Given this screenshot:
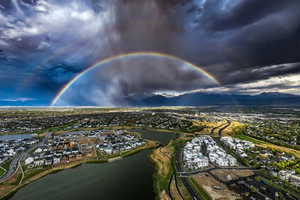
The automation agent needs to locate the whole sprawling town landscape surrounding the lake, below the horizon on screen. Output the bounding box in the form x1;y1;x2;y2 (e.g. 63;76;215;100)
0;107;300;200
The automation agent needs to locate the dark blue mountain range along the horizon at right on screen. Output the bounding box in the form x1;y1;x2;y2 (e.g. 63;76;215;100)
127;92;300;106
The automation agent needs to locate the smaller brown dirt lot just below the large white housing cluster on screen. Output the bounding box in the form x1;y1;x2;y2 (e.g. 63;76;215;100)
211;169;254;182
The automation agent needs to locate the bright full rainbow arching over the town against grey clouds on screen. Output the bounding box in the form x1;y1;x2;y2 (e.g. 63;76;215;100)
51;52;220;106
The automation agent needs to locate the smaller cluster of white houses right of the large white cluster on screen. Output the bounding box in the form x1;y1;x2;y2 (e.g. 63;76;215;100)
220;137;255;158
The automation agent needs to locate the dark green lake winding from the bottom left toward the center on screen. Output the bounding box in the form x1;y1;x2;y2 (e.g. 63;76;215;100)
11;131;175;200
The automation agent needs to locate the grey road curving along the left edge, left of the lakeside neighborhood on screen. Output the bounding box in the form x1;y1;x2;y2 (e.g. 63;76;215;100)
0;133;52;183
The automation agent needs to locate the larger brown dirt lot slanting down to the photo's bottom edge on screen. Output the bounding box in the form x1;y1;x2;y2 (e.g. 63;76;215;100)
193;173;240;200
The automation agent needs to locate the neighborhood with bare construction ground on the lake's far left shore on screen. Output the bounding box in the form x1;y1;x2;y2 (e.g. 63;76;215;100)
24;130;146;168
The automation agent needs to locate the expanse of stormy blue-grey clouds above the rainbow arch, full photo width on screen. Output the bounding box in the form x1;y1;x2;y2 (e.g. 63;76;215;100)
0;0;300;104
